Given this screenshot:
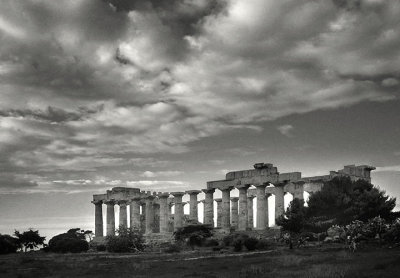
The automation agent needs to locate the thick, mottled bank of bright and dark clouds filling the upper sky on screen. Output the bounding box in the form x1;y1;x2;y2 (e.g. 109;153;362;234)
0;0;400;192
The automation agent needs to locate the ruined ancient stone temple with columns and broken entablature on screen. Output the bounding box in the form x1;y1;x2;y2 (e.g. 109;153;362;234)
92;163;375;237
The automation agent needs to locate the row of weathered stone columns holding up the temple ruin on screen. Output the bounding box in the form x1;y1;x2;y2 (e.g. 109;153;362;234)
93;184;290;236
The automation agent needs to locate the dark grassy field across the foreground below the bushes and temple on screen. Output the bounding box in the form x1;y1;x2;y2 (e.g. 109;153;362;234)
0;246;400;278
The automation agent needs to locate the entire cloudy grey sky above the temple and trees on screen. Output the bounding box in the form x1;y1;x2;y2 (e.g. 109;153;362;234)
0;0;400;238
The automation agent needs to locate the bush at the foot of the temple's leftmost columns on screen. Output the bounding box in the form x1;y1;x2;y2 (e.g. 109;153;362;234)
106;226;144;253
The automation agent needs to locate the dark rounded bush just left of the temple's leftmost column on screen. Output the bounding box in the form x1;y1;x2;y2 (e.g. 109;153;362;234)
45;229;89;253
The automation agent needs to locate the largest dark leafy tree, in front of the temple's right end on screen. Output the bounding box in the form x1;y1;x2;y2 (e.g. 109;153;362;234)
307;177;396;225
